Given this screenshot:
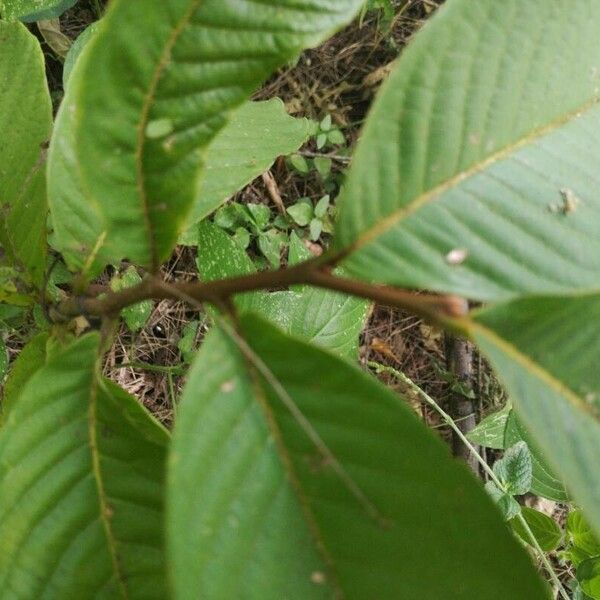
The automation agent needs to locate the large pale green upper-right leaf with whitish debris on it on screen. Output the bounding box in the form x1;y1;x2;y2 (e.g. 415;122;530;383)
336;0;600;300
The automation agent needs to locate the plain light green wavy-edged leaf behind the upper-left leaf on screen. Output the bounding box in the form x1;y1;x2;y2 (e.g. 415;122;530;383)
190;98;310;229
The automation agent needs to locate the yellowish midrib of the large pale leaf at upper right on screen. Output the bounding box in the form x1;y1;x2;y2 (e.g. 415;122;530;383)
343;97;600;254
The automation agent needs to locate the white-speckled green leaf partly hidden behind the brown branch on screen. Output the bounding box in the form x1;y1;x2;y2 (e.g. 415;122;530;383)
198;222;369;359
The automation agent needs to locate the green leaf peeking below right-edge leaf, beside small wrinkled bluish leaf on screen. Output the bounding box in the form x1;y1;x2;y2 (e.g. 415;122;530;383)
504;411;569;502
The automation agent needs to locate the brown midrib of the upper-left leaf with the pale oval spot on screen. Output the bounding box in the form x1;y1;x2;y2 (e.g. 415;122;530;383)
135;0;203;271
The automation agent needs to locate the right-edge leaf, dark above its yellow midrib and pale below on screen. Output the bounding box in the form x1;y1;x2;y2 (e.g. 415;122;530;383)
468;294;600;532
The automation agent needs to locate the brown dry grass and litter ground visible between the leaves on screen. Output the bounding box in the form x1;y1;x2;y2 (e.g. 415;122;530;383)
36;0;504;448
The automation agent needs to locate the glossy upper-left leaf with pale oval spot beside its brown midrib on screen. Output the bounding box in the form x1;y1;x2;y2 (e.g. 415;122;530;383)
57;0;361;268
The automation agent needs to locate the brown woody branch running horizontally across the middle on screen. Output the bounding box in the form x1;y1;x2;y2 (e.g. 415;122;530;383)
50;255;467;322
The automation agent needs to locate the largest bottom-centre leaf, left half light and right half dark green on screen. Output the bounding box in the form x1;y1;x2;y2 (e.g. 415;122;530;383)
167;315;546;600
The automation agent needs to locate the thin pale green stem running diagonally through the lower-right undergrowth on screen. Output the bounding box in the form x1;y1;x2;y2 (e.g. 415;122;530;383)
367;361;570;600
